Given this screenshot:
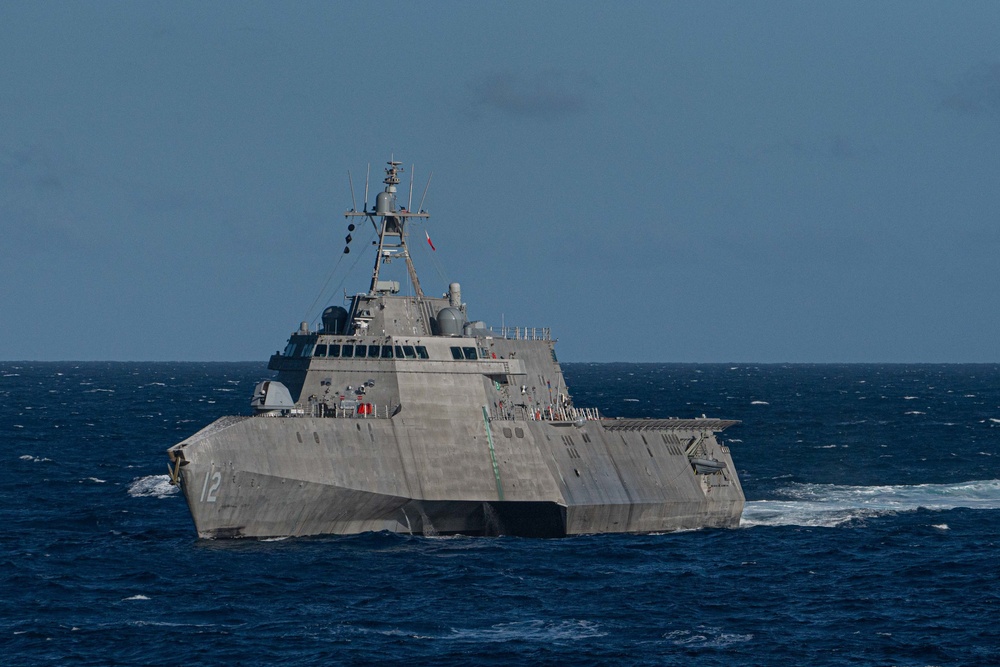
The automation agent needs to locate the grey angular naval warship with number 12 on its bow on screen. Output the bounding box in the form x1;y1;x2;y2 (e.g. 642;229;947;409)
168;161;744;538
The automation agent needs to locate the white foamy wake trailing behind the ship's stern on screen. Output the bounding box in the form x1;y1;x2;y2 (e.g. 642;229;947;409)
740;479;1000;528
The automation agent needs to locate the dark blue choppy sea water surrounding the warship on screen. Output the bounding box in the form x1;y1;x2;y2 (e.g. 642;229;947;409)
0;362;1000;665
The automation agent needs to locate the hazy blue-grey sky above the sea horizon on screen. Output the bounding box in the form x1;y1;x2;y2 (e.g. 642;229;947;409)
0;0;1000;363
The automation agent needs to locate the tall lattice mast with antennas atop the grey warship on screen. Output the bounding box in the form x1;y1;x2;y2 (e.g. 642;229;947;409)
344;160;430;298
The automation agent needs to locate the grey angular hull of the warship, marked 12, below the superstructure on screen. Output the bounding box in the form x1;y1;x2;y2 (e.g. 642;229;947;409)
170;416;744;538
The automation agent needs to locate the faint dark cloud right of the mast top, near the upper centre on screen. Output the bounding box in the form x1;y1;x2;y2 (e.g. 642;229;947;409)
469;71;586;120
